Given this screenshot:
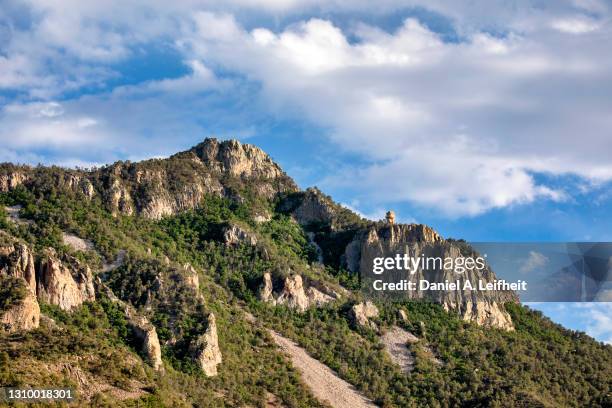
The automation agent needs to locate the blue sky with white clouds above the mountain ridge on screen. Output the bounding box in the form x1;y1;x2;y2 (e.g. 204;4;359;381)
0;0;612;341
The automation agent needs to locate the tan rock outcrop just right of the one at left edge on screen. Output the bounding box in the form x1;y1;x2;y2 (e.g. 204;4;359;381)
36;249;96;310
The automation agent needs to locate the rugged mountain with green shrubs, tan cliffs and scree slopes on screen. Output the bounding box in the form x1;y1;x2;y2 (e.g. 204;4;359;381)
0;139;612;407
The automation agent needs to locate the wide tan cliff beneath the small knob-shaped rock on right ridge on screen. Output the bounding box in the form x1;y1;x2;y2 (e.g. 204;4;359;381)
344;224;518;330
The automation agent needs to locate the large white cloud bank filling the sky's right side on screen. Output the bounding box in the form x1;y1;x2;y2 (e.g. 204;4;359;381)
175;12;612;215
